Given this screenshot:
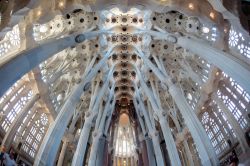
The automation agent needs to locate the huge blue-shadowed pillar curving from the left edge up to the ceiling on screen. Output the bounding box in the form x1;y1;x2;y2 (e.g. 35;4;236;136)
0;31;107;96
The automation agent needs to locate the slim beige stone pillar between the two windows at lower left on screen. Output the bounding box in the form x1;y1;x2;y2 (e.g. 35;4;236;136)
2;94;40;151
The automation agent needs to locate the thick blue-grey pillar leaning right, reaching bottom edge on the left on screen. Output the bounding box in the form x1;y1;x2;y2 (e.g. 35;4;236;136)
34;51;113;165
